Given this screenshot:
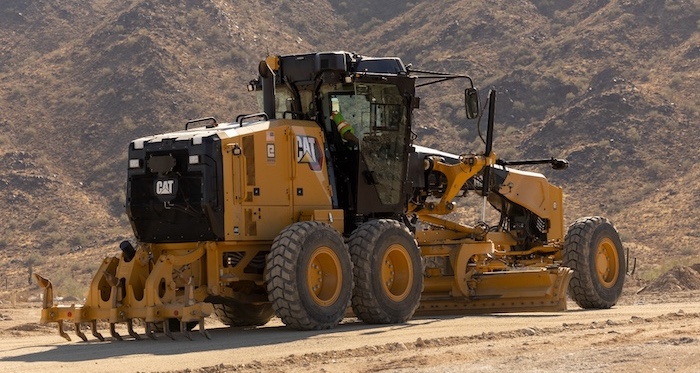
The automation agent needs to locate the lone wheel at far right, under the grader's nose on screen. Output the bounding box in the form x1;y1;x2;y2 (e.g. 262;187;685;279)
563;216;627;309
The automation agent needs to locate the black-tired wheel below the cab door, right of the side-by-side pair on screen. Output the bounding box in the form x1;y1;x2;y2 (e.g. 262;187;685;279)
349;219;423;324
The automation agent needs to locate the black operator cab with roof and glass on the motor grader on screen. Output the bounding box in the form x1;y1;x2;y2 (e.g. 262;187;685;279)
250;52;418;232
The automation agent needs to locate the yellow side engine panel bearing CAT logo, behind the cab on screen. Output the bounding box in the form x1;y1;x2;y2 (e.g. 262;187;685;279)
219;120;332;241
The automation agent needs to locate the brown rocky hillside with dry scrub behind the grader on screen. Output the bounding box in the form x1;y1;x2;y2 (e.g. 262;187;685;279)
0;0;700;296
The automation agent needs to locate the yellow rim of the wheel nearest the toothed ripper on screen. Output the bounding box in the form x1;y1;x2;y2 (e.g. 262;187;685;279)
306;246;343;307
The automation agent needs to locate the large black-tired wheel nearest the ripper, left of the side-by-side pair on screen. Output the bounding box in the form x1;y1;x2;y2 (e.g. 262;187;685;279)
265;221;352;330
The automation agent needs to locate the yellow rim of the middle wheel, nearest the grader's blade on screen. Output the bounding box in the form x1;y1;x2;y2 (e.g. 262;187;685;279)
381;244;413;302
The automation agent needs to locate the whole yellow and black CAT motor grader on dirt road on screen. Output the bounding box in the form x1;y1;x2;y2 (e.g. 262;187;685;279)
37;52;626;340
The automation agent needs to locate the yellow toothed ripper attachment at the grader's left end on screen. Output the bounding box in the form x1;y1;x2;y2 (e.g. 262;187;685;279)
35;241;214;341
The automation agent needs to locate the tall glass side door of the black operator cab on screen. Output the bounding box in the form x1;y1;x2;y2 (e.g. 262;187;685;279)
321;82;409;214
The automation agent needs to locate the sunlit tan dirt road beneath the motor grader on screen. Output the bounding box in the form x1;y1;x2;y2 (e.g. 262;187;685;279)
0;294;700;373
